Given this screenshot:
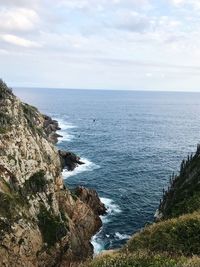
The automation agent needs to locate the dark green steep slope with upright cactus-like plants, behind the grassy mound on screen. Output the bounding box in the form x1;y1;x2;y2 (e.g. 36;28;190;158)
159;145;200;219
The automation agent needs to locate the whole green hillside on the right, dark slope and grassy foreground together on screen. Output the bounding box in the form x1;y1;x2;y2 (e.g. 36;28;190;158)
84;145;200;267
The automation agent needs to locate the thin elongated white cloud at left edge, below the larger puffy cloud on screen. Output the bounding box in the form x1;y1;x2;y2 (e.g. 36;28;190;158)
0;34;41;48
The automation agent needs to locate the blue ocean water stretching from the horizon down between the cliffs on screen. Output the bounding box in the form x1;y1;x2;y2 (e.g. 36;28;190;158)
14;88;200;253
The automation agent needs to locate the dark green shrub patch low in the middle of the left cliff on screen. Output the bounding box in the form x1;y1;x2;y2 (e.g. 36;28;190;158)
38;205;68;247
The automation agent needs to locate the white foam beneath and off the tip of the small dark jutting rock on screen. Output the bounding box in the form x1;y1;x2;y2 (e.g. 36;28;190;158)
62;158;100;179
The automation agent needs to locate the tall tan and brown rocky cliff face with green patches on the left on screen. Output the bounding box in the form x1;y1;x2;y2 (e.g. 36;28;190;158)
0;81;105;267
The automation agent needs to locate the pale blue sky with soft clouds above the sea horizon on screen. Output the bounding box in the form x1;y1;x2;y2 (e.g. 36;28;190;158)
0;0;200;91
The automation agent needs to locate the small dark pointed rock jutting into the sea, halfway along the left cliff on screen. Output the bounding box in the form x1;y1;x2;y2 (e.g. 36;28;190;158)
58;150;85;171
